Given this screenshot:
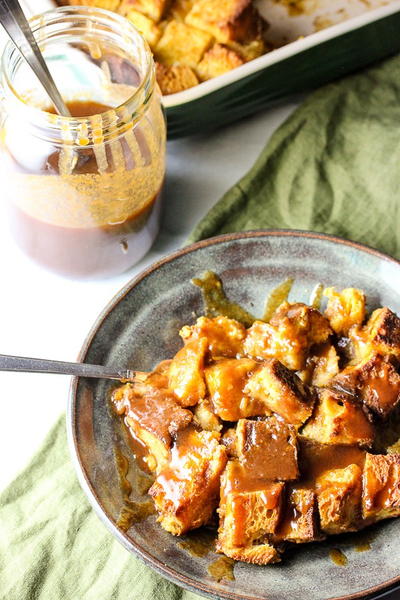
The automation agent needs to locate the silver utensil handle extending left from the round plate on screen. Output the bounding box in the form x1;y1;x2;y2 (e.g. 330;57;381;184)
0;354;135;380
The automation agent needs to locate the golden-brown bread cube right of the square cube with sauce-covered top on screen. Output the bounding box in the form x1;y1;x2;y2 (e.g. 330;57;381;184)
301;389;374;446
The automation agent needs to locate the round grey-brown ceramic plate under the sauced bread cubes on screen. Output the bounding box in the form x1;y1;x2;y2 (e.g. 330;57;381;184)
67;231;400;600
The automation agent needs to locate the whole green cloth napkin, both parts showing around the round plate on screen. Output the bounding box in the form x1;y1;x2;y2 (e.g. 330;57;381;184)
0;52;400;600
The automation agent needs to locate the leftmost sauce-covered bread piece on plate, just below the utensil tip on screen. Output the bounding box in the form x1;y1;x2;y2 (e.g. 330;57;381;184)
112;383;192;473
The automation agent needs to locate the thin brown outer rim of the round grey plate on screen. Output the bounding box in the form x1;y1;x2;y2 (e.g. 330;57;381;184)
66;229;400;600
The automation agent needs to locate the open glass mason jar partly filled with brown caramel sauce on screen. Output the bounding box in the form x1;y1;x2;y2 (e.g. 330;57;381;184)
0;6;166;278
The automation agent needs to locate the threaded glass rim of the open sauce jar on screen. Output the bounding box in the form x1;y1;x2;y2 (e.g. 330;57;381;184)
1;6;155;138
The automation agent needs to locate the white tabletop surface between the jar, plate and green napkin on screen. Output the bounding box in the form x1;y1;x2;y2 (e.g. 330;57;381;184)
0;100;297;488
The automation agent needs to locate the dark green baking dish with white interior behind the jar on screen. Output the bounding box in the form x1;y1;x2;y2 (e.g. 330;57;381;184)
163;0;400;139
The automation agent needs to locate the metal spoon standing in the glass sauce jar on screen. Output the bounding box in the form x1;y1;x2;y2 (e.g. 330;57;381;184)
0;0;71;117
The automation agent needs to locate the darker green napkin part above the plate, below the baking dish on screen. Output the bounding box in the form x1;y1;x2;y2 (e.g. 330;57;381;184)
190;56;400;258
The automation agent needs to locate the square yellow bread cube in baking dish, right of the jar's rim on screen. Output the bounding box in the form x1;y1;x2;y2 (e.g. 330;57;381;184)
155;21;212;69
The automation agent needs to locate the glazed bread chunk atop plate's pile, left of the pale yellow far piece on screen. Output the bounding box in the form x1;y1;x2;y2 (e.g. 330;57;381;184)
244;302;332;371
